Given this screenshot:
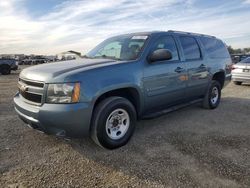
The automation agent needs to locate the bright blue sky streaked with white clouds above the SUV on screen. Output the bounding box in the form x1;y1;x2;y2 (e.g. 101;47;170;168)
0;0;250;54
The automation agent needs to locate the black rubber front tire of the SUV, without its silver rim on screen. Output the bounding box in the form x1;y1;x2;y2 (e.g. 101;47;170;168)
95;98;136;149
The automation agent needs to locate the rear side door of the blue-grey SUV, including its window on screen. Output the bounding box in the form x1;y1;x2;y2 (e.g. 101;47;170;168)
178;35;209;100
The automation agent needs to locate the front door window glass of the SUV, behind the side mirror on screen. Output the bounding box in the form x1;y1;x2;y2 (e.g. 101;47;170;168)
153;36;179;61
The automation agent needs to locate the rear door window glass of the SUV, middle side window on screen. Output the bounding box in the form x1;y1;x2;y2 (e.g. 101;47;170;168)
180;36;201;60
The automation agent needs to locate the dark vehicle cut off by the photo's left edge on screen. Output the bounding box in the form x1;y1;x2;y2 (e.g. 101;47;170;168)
0;59;18;75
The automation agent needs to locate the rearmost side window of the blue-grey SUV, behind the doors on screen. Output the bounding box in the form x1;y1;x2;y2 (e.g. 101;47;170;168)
201;37;229;58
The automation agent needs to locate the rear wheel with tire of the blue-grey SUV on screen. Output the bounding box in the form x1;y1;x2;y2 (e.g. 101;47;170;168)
203;80;221;109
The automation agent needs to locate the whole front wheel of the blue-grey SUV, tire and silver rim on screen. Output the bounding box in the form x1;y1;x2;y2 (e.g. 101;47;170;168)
91;97;136;149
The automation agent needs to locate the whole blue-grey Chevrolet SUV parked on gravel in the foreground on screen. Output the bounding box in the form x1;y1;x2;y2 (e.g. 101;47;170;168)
14;31;232;149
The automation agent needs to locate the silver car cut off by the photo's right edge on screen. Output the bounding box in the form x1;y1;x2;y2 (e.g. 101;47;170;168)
232;57;250;85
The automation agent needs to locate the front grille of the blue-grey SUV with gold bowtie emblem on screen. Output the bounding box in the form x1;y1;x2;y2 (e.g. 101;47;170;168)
18;78;44;104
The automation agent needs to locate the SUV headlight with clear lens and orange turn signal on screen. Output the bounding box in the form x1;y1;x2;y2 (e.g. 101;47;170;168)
46;83;80;103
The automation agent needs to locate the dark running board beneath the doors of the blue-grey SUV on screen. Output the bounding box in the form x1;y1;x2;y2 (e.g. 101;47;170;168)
142;99;203;119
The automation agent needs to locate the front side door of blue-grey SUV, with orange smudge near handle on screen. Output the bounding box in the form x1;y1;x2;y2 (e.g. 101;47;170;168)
143;35;186;111
